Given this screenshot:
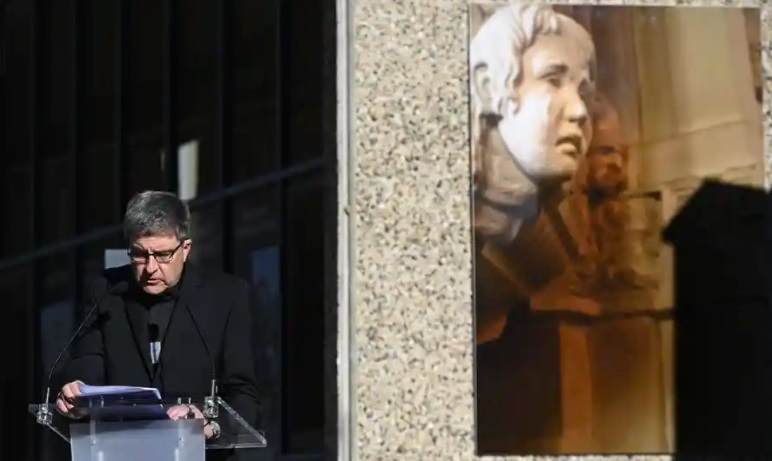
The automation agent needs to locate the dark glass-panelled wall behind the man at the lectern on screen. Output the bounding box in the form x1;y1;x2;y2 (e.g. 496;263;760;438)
0;0;335;459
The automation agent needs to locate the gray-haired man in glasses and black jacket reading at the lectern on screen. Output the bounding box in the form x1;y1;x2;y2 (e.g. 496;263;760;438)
56;191;258;452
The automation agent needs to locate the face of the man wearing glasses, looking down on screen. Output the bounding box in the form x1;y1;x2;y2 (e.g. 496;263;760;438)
129;233;192;295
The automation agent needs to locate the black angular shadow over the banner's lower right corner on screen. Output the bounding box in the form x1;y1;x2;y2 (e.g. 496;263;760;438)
663;180;772;461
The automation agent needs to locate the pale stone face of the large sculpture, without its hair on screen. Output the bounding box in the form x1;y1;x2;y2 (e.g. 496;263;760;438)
499;20;594;181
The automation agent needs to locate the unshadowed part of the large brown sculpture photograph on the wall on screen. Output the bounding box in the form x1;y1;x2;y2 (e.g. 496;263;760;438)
469;3;764;455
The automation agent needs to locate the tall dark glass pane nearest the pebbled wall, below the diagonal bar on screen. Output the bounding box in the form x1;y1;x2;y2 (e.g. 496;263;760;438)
282;172;325;453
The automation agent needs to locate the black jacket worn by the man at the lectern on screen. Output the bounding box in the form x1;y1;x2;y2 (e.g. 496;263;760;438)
55;263;259;446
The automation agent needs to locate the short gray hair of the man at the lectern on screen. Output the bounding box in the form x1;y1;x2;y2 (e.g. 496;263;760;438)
123;190;190;241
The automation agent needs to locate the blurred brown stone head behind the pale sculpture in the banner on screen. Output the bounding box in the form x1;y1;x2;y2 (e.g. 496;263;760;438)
587;109;628;194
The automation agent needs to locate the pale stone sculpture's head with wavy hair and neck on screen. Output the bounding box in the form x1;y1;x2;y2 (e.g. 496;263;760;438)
470;4;595;244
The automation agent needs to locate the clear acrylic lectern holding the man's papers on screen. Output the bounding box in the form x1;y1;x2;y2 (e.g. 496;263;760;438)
29;397;267;461
